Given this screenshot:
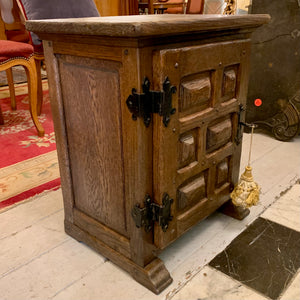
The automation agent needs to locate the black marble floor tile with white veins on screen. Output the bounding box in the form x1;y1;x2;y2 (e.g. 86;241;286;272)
210;218;300;299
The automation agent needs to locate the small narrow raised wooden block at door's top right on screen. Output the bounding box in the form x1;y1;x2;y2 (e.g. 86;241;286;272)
222;65;238;102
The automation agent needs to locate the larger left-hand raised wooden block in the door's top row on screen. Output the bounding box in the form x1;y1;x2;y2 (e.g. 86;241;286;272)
179;72;212;112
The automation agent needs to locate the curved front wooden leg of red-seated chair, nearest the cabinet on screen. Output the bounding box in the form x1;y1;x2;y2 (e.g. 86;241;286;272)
25;57;45;137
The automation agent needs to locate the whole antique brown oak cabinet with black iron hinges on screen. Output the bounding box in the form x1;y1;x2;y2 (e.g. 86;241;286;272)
27;15;269;293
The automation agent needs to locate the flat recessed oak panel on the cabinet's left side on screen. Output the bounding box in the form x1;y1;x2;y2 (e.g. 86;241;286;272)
58;55;127;236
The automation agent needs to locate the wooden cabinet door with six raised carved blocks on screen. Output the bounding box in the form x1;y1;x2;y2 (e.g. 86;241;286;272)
153;40;250;249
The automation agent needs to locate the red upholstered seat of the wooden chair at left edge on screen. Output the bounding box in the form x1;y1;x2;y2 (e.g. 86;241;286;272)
0;40;33;62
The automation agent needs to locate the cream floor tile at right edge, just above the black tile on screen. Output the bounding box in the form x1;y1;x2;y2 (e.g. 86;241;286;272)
261;184;300;231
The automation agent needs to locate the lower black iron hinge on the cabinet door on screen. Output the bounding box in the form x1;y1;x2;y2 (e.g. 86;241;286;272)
131;193;173;232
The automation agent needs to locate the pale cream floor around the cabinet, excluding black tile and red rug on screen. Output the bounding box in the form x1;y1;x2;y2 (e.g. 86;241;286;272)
0;134;300;300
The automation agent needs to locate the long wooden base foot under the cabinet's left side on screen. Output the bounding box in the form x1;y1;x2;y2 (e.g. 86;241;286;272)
65;220;173;294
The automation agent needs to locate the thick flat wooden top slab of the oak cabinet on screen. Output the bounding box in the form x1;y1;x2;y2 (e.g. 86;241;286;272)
26;14;270;37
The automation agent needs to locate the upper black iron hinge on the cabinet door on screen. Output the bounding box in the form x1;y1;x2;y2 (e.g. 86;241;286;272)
126;77;176;127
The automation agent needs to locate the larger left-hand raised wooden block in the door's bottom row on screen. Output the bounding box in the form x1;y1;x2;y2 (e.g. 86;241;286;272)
177;174;206;209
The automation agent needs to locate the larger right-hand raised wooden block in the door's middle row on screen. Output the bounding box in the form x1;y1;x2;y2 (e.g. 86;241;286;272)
206;118;232;152
